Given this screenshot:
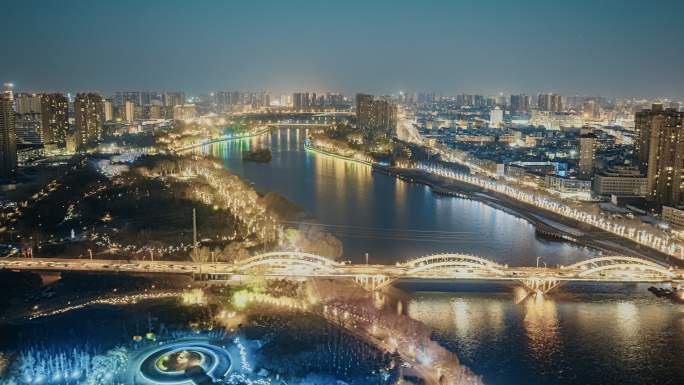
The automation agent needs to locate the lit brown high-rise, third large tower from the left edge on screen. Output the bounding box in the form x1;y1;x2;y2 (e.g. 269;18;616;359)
74;92;104;150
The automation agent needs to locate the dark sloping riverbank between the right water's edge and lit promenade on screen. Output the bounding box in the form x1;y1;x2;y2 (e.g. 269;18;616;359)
373;165;684;266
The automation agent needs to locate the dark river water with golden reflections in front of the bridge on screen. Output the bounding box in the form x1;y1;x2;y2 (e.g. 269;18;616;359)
406;285;684;385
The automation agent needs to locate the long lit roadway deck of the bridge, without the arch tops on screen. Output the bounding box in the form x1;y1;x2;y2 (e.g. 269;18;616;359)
0;257;684;282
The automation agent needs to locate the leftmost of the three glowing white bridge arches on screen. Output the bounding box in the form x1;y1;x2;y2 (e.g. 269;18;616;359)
235;251;341;275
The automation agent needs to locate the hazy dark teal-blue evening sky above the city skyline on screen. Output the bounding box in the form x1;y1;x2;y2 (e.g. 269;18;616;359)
0;0;684;97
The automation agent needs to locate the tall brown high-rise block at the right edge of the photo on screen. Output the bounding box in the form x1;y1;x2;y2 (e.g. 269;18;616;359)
634;104;684;206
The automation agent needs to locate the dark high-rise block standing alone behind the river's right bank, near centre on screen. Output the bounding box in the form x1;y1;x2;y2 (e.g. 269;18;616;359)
356;94;397;138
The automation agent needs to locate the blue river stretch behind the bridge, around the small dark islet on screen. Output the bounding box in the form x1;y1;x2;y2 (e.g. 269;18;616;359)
201;128;594;266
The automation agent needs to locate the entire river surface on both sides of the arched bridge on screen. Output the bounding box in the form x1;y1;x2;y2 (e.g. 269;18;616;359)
202;128;684;385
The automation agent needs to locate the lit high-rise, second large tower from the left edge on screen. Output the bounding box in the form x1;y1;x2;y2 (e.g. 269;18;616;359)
40;94;69;147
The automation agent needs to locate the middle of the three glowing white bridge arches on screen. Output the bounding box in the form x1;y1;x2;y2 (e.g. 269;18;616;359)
399;254;506;276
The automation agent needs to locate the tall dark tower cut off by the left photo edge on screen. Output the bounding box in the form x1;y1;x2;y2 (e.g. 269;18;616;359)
0;84;17;178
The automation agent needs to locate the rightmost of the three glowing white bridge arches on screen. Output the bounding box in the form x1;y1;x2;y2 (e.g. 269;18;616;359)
561;255;676;281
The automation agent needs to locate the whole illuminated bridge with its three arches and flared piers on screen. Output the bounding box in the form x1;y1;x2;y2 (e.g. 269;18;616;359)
0;251;684;293
